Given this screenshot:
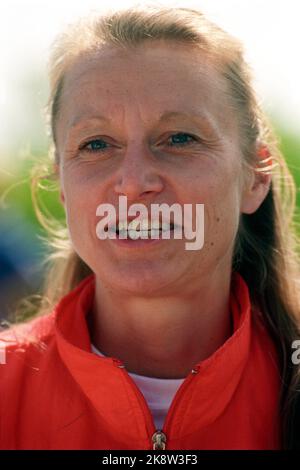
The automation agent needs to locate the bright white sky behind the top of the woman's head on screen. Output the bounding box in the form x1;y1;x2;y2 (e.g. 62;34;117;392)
0;0;300;167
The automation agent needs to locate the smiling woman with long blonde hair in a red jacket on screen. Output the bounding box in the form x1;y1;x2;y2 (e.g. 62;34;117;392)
0;7;299;450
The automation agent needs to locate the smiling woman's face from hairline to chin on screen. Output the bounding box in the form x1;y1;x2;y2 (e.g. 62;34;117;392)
56;42;257;294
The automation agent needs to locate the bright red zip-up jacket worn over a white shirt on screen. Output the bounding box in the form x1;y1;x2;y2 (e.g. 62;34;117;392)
0;273;280;450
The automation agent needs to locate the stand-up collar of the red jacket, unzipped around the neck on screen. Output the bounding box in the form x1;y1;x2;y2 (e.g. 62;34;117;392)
55;272;251;445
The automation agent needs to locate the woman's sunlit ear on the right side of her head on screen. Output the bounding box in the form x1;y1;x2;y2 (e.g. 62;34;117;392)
241;143;272;214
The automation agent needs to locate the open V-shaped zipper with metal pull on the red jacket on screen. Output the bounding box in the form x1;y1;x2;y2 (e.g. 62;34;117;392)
112;358;200;450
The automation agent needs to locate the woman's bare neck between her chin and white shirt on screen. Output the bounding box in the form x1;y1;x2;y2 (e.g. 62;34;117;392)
89;273;232;379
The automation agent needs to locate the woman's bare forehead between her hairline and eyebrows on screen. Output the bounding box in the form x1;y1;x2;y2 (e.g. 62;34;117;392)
61;41;235;135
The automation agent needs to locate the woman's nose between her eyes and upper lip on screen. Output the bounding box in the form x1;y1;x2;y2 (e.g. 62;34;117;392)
114;145;164;201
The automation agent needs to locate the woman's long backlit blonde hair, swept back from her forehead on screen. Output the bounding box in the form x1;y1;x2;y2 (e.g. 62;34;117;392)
24;6;300;448
